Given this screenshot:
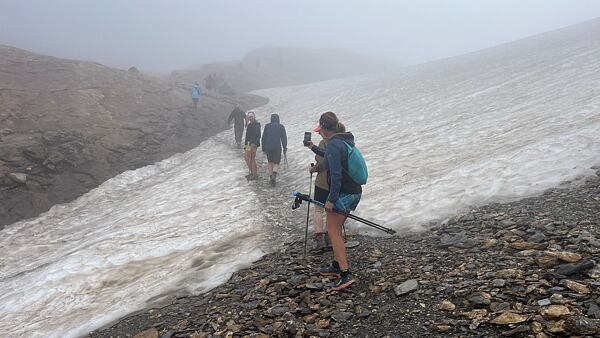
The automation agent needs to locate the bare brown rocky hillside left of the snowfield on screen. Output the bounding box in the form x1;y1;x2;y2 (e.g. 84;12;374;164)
0;45;268;229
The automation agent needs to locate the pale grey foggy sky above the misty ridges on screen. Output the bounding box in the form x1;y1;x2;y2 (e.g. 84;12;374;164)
0;0;600;71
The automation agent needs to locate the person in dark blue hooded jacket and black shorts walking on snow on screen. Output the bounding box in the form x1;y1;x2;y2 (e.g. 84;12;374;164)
262;114;287;186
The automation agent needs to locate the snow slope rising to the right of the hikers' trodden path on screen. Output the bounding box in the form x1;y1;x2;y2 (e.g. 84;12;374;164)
250;20;600;228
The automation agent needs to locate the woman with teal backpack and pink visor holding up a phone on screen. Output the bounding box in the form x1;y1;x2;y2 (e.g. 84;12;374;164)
307;112;362;291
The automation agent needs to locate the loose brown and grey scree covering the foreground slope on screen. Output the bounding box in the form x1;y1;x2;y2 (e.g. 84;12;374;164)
88;171;600;338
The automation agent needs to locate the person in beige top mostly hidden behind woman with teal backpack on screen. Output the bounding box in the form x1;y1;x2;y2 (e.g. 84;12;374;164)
309;117;346;252
